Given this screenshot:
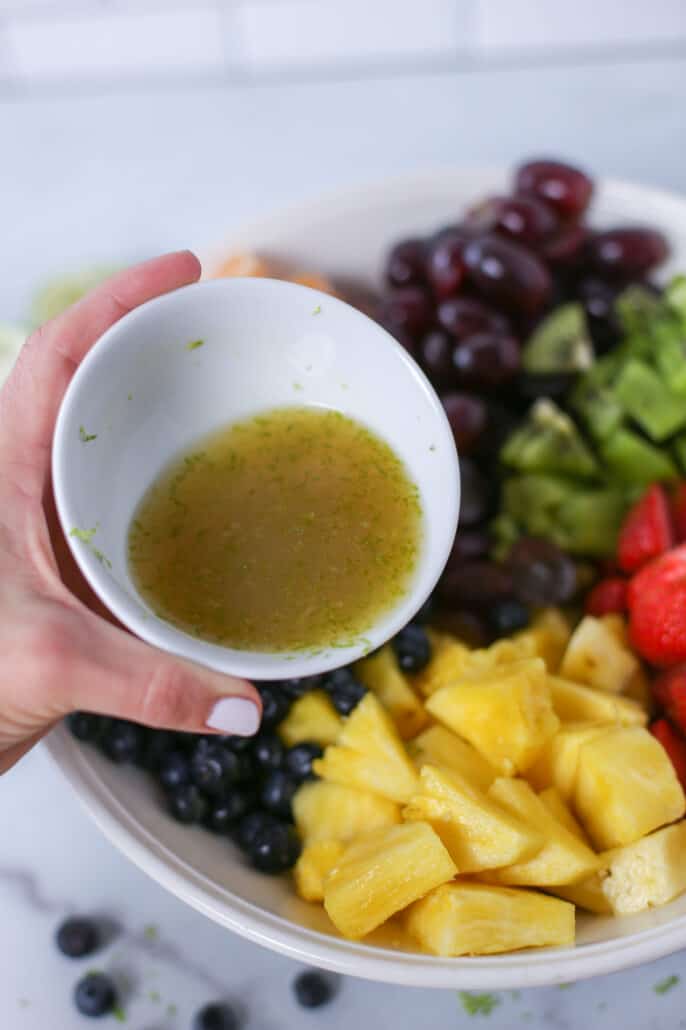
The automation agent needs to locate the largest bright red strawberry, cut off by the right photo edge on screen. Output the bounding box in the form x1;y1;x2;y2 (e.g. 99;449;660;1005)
627;544;686;667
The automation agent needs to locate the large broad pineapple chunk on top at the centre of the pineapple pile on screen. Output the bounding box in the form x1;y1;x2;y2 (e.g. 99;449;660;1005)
426;658;559;776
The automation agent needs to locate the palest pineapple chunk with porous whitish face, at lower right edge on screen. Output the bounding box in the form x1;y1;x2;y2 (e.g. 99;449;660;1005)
602;822;686;916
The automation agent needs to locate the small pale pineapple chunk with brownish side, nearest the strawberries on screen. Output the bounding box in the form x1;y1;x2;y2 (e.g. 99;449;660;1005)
559;615;640;694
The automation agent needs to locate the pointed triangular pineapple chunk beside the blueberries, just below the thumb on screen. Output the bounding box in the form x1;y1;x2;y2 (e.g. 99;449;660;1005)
312;693;418;802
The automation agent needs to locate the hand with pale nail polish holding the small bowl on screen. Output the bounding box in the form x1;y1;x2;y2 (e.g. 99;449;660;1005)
0;251;262;773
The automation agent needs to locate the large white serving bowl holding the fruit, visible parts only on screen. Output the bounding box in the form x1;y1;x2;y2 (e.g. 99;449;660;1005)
47;170;686;989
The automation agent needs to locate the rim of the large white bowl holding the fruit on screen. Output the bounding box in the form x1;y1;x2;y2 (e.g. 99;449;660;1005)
43;164;686;990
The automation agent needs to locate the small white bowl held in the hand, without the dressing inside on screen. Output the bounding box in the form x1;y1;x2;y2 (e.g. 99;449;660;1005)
53;278;459;680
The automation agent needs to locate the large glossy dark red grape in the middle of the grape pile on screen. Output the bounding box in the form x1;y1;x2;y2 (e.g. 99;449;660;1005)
462;234;551;315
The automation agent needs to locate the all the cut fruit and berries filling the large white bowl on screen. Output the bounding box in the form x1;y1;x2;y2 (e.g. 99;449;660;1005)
69;161;686;956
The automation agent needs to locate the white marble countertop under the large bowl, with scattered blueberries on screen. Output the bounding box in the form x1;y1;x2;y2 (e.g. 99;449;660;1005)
0;59;686;1030
